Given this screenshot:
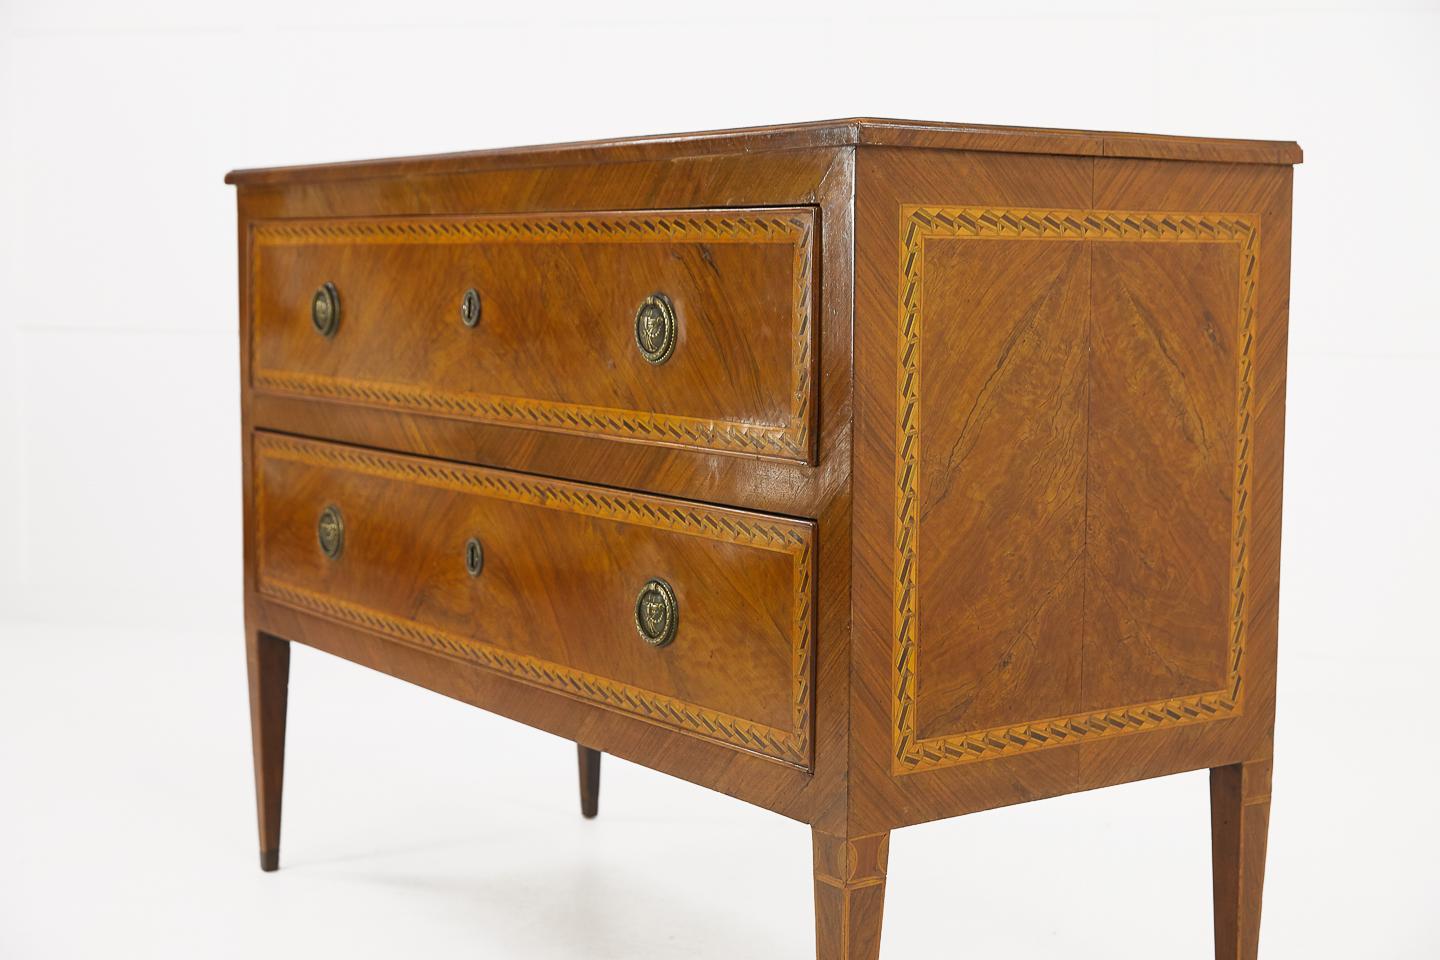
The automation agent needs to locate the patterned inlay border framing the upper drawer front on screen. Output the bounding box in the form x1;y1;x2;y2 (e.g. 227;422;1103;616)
252;209;815;462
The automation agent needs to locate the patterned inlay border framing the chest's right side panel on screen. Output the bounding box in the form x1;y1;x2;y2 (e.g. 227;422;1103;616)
891;204;1260;774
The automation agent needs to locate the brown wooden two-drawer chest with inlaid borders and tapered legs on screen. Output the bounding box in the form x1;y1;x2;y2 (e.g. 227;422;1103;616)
229;119;1300;960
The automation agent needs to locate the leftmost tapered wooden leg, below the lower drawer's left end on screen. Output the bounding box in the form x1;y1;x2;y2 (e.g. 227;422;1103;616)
246;630;289;871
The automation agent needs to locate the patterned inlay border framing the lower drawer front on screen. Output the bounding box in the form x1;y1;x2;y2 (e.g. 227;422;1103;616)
255;435;814;770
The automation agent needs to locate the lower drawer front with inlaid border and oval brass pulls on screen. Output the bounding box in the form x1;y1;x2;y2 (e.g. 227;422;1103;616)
253;433;814;769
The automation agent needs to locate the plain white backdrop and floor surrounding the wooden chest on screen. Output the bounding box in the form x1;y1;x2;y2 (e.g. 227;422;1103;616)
0;0;1440;960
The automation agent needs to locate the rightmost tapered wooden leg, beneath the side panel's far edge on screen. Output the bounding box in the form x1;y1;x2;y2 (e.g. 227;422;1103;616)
1210;760;1270;960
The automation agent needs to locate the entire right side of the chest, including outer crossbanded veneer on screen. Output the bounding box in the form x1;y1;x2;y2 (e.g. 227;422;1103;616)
852;150;1290;832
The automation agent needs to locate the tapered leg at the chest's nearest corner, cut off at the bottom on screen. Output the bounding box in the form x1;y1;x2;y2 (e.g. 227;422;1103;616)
812;830;890;960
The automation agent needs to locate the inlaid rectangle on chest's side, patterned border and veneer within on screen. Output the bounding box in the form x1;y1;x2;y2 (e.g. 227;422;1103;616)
893;206;1259;773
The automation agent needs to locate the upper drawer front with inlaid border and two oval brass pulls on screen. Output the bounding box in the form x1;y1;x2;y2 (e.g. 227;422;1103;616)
241;209;815;461
